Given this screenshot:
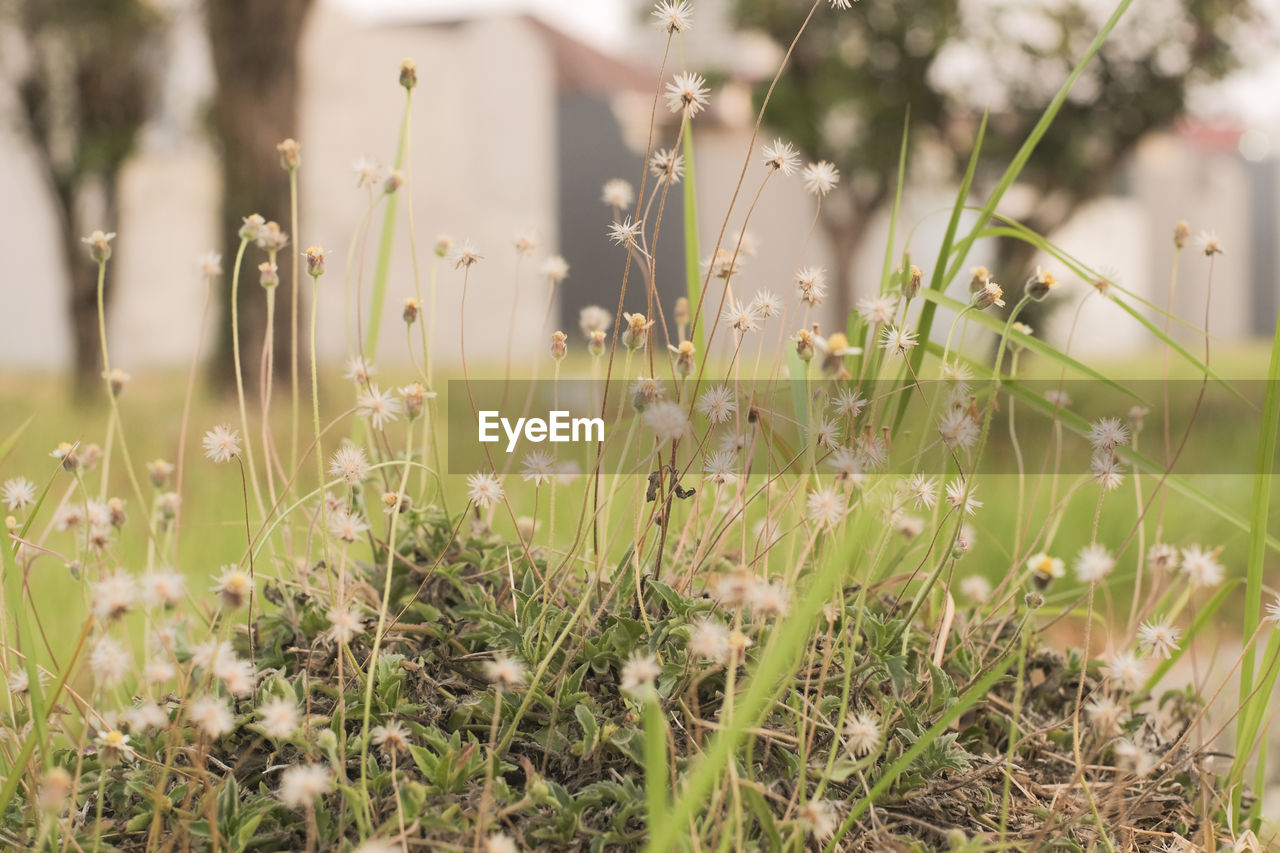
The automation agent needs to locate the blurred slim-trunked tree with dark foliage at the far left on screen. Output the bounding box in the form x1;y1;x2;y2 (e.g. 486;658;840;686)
4;0;164;396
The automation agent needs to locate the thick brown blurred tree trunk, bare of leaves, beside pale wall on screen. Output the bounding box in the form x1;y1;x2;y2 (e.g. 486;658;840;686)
205;0;312;386
